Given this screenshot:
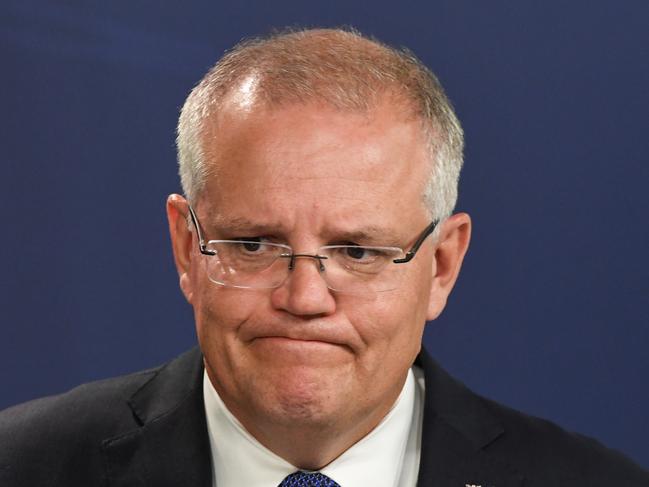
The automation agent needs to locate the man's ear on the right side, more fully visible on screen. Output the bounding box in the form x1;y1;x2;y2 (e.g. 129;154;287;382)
426;213;471;321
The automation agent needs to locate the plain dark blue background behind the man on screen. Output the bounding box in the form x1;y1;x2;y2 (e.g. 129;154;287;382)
0;0;649;467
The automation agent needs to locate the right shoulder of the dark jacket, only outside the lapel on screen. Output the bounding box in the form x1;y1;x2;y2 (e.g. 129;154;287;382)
480;388;649;487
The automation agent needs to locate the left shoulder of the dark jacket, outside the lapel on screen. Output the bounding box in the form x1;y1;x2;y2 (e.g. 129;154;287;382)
0;360;159;486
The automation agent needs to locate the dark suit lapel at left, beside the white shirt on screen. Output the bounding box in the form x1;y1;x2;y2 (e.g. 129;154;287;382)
102;349;212;487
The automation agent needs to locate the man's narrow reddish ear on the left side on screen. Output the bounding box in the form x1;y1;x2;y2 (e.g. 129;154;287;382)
167;194;193;303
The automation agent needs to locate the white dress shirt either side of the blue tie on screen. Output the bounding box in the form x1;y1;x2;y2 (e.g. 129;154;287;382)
203;367;424;487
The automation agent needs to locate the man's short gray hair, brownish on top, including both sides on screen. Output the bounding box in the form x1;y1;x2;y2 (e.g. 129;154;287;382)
176;29;464;219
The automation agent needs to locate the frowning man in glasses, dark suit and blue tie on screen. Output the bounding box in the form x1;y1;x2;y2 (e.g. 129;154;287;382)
0;30;649;487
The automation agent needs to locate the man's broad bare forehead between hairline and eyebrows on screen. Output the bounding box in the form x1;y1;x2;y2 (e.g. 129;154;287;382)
201;104;429;231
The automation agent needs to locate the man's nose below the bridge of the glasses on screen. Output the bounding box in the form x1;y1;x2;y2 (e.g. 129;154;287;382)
272;254;336;317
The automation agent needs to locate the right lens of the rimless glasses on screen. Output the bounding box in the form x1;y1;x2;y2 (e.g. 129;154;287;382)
318;245;405;294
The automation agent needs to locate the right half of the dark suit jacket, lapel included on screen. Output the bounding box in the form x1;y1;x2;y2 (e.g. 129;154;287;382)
417;351;649;487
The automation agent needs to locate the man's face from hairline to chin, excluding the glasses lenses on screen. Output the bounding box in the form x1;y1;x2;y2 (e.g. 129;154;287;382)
167;97;461;440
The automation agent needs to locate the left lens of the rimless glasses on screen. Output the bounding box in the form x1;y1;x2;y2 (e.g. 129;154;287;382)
206;240;291;289
